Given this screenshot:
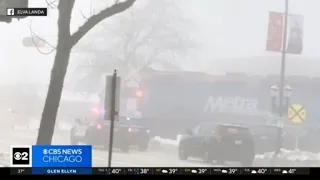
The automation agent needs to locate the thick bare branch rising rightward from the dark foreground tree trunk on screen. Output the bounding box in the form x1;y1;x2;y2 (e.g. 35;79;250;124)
71;0;136;46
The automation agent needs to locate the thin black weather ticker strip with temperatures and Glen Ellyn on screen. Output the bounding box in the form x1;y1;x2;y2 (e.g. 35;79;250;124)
6;167;314;175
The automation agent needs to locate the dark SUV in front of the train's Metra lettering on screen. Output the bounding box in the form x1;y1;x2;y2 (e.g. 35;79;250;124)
179;123;255;166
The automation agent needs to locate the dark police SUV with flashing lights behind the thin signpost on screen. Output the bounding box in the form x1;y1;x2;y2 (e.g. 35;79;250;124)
70;118;151;152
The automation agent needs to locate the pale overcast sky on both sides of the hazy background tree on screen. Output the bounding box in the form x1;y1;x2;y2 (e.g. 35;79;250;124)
0;0;320;84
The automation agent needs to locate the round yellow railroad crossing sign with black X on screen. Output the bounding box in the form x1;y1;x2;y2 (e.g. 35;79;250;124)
288;104;307;124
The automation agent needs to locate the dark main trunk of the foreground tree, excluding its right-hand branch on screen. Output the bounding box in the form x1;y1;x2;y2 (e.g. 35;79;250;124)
37;0;74;145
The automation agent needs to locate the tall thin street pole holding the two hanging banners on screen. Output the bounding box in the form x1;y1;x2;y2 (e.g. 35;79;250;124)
275;0;289;159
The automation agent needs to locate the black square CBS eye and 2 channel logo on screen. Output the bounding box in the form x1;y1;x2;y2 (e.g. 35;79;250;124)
11;147;30;166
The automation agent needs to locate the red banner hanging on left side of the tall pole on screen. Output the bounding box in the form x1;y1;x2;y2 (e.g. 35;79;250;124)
266;12;284;52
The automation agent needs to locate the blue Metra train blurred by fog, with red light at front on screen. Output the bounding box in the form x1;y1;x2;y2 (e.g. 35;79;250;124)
120;71;320;137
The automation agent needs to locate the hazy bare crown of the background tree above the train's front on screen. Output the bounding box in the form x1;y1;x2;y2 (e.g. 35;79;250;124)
71;0;194;90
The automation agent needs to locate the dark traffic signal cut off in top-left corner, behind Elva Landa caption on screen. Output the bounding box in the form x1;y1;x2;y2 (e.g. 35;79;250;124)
0;0;29;23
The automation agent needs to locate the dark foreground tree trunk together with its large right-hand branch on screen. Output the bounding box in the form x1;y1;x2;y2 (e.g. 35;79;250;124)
37;0;135;145
